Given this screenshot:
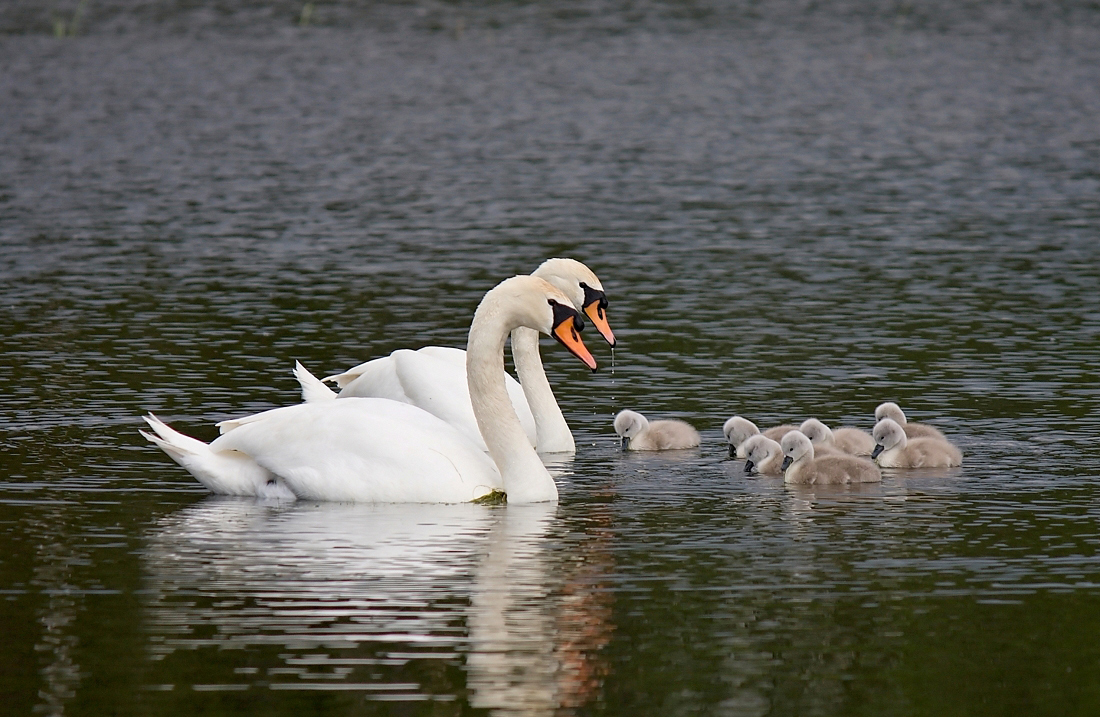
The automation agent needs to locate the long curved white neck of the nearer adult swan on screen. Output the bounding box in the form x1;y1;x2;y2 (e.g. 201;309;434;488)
466;295;558;503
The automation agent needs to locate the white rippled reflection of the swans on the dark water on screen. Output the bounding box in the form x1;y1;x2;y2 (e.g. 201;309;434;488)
143;490;613;714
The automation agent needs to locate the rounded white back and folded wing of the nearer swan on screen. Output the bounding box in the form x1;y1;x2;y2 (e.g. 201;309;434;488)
210;398;502;503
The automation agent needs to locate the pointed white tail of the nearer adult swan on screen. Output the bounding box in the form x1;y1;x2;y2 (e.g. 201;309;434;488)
139;413;279;498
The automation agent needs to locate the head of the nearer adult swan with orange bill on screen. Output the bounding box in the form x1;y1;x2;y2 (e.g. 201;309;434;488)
484;276;596;371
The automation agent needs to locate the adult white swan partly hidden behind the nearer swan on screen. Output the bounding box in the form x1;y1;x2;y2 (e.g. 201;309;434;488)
294;258;615;453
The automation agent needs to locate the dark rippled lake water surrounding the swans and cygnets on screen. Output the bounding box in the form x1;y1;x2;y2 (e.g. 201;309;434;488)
0;0;1100;715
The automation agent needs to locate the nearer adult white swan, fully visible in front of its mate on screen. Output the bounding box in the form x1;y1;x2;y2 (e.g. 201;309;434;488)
142;276;596;503
